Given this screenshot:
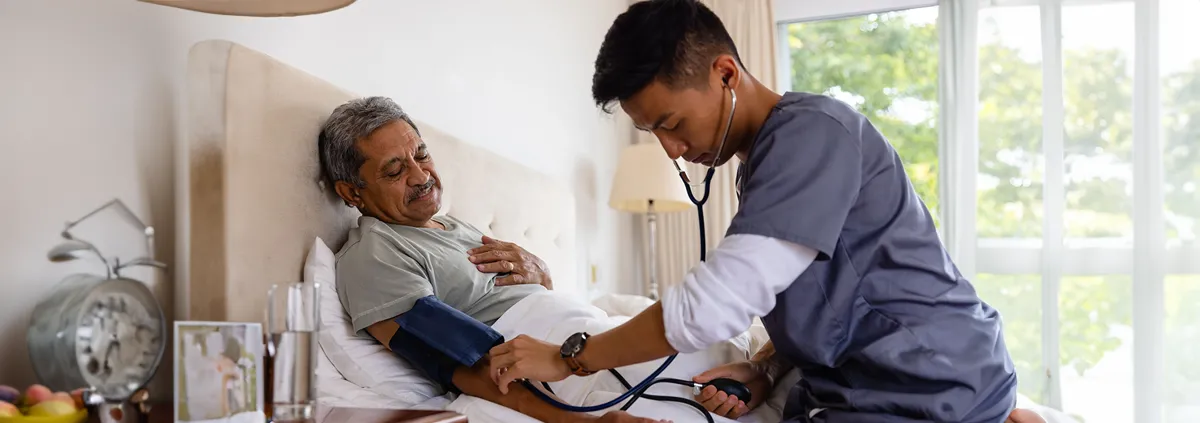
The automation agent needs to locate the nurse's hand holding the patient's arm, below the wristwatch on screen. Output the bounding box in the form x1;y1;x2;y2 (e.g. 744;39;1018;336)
488;335;571;394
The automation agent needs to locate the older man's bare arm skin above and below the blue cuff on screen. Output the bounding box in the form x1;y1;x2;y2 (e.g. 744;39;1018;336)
367;316;654;423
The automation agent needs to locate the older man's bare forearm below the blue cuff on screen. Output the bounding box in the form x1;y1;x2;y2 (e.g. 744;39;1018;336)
454;358;598;423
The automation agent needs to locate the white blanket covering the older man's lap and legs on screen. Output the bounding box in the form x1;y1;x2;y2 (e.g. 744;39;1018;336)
445;291;790;422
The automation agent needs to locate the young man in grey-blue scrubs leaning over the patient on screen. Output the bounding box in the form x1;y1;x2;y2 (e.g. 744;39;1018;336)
491;0;1042;423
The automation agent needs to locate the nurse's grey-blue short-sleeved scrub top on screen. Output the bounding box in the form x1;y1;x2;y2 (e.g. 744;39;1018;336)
727;93;1016;423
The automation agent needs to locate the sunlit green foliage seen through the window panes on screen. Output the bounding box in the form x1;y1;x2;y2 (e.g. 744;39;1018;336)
788;8;1200;408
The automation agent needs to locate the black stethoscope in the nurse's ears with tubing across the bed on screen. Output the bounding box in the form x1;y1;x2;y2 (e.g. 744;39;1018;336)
521;81;750;423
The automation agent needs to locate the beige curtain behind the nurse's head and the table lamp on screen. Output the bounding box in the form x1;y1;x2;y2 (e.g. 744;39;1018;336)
631;0;776;290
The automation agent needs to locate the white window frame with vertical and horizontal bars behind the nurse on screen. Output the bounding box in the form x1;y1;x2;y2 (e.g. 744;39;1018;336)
775;0;1185;415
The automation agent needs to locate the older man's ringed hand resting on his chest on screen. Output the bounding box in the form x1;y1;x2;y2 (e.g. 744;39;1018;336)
467;236;554;290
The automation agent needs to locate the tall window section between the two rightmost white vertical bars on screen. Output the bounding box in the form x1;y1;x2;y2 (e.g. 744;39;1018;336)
1048;2;1135;423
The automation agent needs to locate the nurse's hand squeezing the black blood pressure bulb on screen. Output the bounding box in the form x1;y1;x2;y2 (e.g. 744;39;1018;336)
691;361;770;418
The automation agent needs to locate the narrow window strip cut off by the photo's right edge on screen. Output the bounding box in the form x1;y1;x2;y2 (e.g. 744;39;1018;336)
1158;0;1200;423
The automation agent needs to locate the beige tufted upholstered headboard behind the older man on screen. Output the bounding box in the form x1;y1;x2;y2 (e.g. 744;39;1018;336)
184;41;584;322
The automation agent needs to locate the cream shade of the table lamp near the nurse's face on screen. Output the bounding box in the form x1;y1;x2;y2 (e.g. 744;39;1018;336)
608;143;695;213
